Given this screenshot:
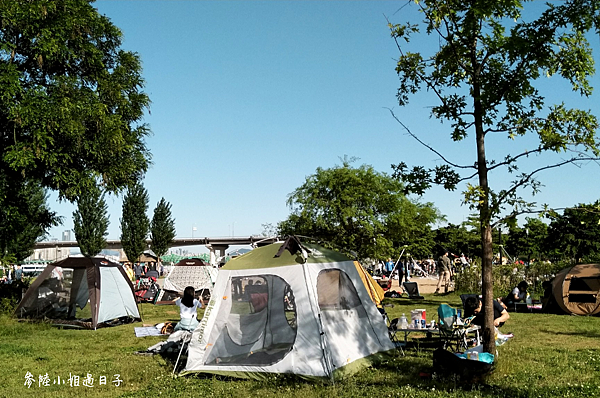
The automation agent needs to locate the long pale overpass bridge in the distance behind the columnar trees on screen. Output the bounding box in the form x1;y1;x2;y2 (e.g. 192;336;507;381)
34;236;279;265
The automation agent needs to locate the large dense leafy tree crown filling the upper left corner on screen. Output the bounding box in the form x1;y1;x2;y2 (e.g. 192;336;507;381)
0;0;151;257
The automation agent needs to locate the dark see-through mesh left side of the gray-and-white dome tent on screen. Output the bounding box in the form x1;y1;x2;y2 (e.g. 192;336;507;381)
18;267;92;321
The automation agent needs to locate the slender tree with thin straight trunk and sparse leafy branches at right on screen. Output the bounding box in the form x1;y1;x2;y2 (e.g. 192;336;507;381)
390;0;600;352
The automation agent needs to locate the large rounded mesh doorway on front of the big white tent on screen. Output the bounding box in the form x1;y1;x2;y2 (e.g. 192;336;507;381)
204;275;297;366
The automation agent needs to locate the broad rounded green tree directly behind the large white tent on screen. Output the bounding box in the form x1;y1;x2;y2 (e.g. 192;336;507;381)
278;160;439;259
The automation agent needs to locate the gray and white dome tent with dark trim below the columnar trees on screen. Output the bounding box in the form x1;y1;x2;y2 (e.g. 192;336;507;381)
15;257;140;329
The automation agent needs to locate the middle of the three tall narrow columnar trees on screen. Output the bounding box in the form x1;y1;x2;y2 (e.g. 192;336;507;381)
121;183;150;261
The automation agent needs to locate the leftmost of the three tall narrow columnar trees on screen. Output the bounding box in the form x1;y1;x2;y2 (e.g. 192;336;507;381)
73;183;110;257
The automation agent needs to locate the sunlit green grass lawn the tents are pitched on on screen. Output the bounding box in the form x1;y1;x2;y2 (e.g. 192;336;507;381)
0;294;600;398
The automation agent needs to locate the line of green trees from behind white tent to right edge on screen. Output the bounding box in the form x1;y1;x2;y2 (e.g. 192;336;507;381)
271;159;600;263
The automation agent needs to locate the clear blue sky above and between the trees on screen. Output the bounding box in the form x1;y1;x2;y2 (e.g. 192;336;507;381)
50;0;600;246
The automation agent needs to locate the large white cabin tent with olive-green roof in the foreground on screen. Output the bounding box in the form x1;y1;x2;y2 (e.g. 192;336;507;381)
184;237;394;379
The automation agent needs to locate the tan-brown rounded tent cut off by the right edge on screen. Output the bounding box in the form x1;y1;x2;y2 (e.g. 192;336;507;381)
552;264;600;315
